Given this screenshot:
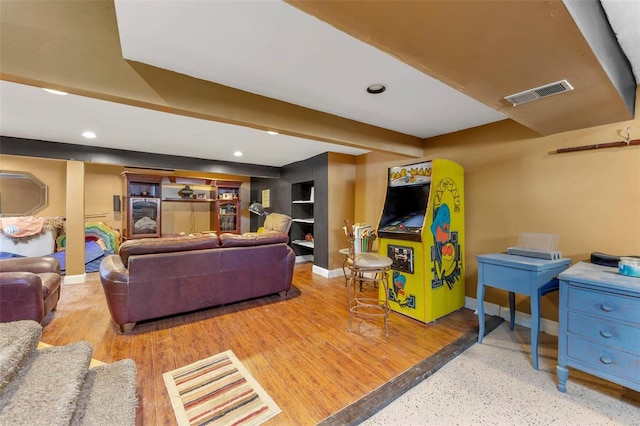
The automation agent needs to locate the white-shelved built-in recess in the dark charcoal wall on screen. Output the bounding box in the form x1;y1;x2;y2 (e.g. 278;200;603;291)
291;181;314;260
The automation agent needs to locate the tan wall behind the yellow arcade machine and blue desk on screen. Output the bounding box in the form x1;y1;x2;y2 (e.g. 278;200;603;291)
356;87;640;320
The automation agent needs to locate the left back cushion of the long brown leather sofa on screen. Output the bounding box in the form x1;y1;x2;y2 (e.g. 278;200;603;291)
118;234;220;265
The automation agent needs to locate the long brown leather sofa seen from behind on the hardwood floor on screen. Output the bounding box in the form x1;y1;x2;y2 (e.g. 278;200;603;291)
100;233;295;332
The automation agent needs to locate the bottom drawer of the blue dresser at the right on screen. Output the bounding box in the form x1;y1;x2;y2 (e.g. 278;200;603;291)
568;335;640;389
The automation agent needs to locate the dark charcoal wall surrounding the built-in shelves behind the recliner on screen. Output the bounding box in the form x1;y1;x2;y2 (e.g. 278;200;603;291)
251;153;329;269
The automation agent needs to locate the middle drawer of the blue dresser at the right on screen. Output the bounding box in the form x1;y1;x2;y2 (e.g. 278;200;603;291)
568;312;640;355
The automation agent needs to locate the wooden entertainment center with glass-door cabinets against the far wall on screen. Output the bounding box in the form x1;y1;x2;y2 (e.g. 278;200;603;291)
122;171;242;239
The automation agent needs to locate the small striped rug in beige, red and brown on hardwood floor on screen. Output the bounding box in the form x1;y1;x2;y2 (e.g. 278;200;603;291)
162;350;281;426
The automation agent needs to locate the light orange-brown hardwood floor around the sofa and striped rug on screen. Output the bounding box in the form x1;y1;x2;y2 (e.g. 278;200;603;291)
41;263;478;425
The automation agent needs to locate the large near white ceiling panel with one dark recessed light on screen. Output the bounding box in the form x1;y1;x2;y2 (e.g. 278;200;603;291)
115;0;505;138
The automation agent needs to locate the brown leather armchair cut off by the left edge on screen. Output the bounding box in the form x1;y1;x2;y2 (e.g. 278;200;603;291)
0;256;62;323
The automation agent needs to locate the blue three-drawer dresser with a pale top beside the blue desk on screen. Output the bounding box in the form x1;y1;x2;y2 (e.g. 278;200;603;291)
556;262;640;392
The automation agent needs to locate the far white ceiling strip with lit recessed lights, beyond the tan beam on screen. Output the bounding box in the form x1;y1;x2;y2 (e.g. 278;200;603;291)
0;81;367;167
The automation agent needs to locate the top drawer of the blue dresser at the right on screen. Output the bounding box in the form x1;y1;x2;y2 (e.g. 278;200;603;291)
568;286;640;324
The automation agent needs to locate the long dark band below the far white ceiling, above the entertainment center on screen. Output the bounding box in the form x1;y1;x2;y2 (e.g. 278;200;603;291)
0;136;280;178
